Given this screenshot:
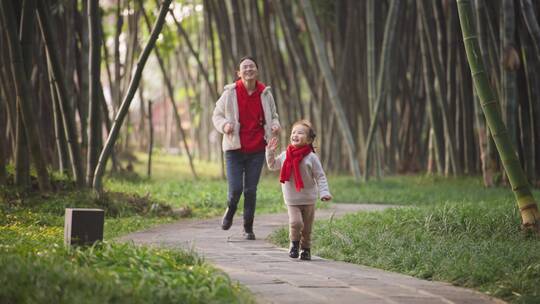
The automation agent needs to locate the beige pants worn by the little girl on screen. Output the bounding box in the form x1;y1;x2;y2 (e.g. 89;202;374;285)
287;204;315;248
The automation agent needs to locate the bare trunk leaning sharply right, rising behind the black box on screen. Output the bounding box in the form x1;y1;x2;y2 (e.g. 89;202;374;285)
93;0;172;194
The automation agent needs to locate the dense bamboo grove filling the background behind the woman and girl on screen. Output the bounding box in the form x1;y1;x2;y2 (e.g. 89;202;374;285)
0;0;540;191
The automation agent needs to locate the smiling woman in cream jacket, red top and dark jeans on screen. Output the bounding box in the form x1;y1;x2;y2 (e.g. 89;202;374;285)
212;57;280;240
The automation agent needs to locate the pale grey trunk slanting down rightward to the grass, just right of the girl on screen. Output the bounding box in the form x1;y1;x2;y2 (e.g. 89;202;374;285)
300;0;360;180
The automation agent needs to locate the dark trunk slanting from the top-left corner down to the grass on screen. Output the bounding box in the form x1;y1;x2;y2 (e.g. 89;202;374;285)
1;1;51;191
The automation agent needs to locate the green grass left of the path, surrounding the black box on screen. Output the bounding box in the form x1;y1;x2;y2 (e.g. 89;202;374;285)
0;154;253;303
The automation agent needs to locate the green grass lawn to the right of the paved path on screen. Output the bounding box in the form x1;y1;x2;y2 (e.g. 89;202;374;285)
271;176;540;303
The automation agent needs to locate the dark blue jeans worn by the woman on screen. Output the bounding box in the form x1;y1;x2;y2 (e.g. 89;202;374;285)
225;150;265;230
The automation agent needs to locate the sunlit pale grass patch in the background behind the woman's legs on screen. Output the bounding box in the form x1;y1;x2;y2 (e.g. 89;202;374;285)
105;153;286;218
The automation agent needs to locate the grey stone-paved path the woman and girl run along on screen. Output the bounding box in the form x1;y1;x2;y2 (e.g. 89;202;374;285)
121;204;504;304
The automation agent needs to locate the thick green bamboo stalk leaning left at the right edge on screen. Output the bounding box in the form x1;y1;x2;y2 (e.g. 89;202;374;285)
457;0;540;232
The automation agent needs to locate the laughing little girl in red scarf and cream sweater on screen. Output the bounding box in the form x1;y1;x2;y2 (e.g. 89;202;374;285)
266;120;332;260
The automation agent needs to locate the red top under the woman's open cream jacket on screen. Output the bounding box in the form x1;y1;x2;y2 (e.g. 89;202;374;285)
236;79;266;153
